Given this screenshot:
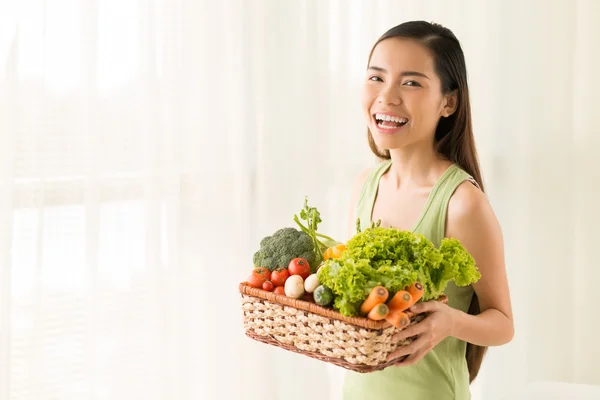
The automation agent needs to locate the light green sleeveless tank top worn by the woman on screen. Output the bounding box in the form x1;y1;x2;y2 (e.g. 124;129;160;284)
343;160;474;400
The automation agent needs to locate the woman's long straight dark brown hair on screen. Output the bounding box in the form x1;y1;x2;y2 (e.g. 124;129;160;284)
368;21;487;382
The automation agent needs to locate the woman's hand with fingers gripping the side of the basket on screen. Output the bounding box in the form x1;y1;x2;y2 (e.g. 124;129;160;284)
387;300;457;367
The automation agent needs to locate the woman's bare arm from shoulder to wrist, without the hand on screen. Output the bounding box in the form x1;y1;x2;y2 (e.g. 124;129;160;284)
446;183;514;346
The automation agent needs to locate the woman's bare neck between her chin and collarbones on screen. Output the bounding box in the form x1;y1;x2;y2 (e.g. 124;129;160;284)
387;146;452;189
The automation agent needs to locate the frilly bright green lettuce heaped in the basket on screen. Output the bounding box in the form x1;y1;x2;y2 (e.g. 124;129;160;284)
317;227;481;316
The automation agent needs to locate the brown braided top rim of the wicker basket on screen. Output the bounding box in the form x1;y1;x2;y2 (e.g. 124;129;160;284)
239;282;448;330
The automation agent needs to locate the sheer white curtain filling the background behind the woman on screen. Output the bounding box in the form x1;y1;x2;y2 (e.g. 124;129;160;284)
0;0;600;400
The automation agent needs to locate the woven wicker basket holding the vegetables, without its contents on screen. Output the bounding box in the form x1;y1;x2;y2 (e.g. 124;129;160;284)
239;283;448;372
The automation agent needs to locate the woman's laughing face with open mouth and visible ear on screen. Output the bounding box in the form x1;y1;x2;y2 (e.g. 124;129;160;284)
362;38;455;150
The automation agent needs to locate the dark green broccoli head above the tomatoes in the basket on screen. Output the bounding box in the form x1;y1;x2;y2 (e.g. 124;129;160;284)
253;228;320;272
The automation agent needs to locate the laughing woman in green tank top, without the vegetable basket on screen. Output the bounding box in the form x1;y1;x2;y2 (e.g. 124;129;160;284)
344;21;513;400
